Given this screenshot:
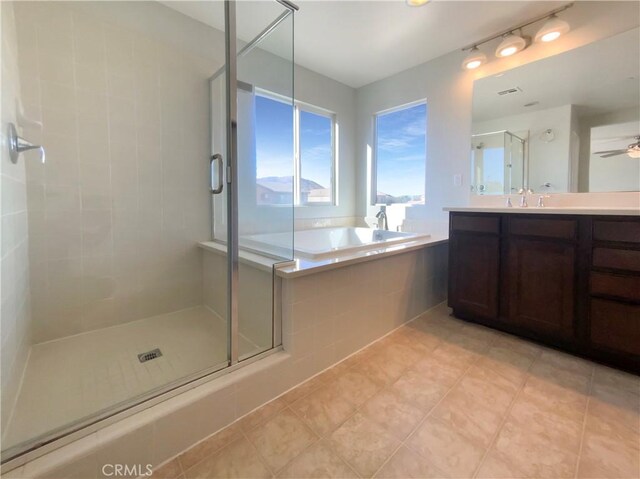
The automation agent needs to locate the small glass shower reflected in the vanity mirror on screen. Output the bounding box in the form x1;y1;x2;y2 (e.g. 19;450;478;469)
471;131;526;195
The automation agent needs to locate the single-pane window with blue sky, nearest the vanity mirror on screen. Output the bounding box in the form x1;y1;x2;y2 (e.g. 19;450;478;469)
371;103;427;204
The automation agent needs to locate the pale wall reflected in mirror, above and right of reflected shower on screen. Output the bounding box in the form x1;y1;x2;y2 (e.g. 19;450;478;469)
471;105;572;193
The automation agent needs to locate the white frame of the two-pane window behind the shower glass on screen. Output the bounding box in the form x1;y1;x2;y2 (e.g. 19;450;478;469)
254;88;338;207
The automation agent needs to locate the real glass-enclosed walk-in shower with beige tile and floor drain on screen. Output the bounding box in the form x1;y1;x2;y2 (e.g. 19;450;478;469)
0;0;295;462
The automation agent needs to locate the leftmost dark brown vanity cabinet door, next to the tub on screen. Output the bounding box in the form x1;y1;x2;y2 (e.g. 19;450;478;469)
449;233;500;319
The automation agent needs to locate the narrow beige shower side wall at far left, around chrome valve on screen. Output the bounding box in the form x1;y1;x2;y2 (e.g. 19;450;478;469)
0;2;32;438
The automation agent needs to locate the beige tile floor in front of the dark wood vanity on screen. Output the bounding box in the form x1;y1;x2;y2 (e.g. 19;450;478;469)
154;307;640;479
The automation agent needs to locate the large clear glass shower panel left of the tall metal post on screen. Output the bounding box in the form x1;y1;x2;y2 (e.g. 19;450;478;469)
0;1;229;461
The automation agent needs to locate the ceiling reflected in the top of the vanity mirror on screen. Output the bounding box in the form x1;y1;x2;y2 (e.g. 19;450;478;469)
473;28;640;122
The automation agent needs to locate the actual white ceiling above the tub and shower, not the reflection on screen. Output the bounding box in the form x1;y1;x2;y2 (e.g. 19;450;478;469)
163;0;566;88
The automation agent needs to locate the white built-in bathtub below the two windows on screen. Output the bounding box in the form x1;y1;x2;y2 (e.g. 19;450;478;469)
240;227;429;260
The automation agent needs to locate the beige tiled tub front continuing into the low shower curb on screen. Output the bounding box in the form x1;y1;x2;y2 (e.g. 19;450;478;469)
2;243;447;479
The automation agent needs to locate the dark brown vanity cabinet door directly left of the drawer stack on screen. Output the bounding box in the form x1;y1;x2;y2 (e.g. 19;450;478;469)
507;237;576;337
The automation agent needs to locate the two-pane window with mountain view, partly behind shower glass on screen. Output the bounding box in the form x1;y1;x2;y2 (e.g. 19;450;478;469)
255;93;336;205
